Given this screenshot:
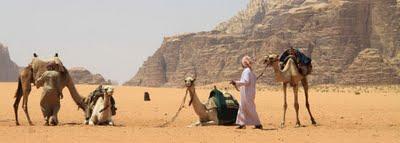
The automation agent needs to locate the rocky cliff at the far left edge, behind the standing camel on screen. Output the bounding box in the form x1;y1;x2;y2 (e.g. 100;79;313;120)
0;43;18;82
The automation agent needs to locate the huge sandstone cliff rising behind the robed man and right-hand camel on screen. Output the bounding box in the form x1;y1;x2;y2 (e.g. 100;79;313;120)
125;0;400;86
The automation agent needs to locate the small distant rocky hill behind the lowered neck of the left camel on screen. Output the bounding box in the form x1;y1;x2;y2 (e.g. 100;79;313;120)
68;67;111;85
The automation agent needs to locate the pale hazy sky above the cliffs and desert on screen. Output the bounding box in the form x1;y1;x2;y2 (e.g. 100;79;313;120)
0;0;248;83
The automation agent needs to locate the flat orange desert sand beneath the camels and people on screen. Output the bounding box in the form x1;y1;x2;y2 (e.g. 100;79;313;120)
0;83;400;143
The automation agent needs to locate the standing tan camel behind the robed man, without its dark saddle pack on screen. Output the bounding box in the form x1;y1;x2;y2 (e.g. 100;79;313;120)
264;54;317;128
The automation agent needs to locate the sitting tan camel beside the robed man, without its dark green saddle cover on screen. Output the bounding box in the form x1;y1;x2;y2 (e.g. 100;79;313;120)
185;77;238;127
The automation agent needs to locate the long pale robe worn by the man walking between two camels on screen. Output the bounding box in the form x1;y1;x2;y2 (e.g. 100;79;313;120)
236;68;261;125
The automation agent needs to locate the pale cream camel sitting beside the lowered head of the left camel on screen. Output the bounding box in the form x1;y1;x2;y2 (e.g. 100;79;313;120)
89;86;114;126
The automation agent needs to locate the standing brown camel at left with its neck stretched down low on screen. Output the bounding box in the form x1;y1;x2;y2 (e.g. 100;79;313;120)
13;54;86;126
